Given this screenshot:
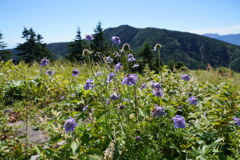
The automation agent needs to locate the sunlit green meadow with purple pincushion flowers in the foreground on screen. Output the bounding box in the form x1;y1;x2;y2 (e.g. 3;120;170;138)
0;39;240;160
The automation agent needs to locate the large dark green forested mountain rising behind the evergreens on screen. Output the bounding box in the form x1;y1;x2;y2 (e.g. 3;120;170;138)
104;25;240;71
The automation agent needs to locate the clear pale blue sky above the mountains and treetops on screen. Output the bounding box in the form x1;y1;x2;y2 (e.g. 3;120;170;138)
0;0;240;48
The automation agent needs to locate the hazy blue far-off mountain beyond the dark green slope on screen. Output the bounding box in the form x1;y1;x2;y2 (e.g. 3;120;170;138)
204;33;240;46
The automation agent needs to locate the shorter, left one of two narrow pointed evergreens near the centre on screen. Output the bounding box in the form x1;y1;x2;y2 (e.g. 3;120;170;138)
66;28;84;61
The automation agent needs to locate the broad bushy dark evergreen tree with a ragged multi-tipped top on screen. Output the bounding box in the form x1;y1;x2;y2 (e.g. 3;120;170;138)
16;28;53;63
